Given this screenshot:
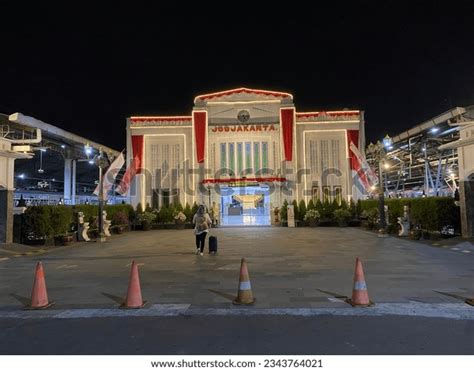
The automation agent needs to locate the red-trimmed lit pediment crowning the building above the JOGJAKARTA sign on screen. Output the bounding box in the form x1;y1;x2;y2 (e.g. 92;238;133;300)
194;88;293;103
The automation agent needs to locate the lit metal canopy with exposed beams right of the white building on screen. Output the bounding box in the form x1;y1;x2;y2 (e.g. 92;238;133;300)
367;106;474;197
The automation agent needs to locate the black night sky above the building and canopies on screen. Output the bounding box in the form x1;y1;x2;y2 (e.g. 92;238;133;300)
0;0;474;150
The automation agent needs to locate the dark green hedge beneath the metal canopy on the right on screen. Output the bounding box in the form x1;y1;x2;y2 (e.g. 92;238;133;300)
360;197;460;231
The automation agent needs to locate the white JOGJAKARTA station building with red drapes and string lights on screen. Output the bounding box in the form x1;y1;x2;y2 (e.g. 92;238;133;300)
127;88;365;224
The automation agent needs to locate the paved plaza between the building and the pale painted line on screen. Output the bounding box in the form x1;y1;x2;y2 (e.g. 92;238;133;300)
0;227;474;309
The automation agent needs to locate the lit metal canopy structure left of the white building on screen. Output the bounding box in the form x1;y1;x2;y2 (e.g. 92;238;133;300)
0;113;120;204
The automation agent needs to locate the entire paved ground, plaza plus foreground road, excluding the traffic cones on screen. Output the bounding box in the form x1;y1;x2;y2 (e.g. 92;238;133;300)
0;228;474;354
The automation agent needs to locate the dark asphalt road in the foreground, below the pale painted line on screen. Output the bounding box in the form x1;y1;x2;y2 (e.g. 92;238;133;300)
0;316;474;355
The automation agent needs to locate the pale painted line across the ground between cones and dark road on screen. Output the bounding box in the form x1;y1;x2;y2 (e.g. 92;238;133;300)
0;302;474;320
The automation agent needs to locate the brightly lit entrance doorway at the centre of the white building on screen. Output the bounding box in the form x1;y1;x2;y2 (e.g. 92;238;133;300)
220;185;270;226
